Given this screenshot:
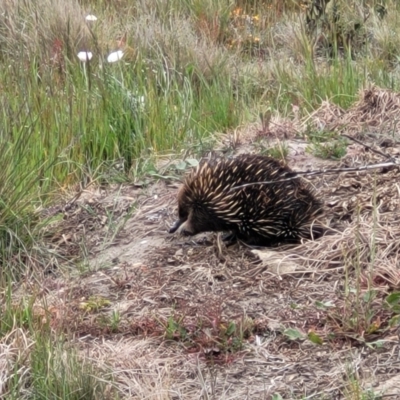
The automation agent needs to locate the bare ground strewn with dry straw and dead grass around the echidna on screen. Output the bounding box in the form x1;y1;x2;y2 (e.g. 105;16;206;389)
21;88;400;399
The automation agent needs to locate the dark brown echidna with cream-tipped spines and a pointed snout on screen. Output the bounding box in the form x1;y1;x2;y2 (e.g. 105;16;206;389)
169;155;323;246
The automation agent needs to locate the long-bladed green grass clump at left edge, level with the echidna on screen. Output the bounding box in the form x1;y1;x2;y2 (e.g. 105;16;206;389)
0;117;54;281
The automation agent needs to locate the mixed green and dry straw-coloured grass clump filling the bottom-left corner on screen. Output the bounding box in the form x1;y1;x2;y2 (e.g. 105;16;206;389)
0;285;115;399
